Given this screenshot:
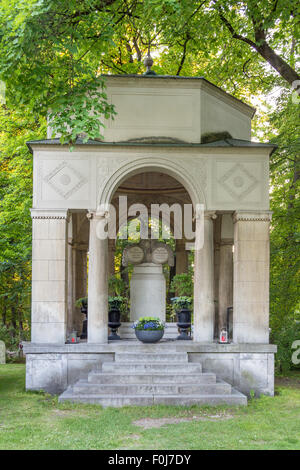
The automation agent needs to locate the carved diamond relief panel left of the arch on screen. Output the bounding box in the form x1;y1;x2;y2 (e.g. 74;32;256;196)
44;161;87;199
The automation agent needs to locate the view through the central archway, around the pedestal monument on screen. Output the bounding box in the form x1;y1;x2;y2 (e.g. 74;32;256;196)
109;170;194;328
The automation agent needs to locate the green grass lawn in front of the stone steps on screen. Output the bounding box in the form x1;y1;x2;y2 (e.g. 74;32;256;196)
0;364;300;450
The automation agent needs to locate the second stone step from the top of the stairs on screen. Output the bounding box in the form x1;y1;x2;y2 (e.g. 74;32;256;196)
102;362;202;374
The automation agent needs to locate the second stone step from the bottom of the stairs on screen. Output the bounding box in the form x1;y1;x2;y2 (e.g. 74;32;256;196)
73;382;231;396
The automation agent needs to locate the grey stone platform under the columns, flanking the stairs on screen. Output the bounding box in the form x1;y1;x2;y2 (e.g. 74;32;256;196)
23;339;276;396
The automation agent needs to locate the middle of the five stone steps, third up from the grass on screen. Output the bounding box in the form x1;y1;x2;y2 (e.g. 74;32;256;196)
88;372;216;384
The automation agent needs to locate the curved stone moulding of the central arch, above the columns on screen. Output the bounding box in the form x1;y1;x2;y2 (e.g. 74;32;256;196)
97;156;206;208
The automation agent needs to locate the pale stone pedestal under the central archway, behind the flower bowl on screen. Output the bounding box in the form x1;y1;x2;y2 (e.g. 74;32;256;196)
130;263;166;321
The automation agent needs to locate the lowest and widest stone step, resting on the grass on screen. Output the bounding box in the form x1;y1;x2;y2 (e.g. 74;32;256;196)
59;387;247;407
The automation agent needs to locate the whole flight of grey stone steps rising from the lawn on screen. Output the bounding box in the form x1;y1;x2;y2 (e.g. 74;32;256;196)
59;352;247;407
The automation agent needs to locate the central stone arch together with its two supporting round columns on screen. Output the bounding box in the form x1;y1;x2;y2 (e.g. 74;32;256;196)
88;162;214;343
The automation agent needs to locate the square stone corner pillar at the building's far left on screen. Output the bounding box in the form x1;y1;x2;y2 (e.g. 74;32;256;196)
31;209;68;344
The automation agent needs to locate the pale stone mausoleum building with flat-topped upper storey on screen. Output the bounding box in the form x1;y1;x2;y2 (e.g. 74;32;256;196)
24;71;276;406
